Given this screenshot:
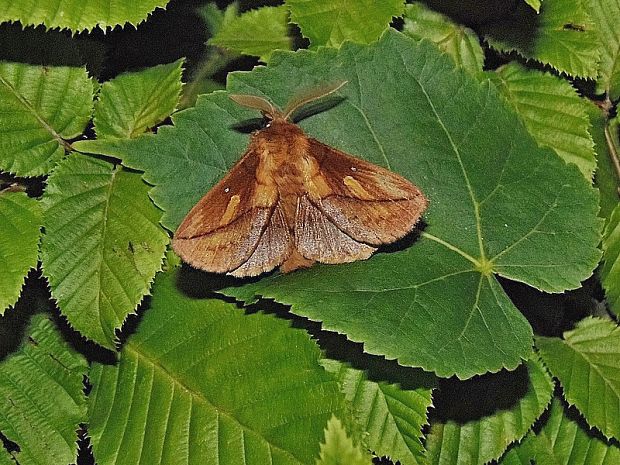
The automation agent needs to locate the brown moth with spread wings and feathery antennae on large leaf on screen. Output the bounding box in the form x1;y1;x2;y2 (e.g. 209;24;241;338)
172;82;428;277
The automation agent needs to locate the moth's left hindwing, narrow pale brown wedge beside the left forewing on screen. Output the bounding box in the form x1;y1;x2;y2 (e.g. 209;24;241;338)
229;202;293;277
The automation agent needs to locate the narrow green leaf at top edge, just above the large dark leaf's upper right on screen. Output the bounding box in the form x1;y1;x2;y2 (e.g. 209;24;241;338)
403;2;484;73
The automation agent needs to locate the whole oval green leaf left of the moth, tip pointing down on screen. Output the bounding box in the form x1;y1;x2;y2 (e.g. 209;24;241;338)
41;154;168;349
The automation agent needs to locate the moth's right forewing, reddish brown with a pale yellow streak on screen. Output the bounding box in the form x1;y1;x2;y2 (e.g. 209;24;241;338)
308;139;428;246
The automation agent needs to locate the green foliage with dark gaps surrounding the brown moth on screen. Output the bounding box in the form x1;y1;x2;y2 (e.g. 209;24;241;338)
0;0;620;464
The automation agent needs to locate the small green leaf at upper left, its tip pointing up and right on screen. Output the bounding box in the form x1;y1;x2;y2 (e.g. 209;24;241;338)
93;60;183;138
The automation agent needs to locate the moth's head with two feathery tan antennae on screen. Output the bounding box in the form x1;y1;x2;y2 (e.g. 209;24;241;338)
230;81;348;126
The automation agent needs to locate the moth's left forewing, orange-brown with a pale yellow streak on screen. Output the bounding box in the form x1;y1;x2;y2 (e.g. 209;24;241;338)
172;147;277;273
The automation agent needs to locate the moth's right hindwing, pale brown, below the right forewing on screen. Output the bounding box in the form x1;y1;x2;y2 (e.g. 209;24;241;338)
295;195;376;263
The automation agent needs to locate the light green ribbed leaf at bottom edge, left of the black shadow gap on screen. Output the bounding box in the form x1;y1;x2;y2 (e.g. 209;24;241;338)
321;359;432;465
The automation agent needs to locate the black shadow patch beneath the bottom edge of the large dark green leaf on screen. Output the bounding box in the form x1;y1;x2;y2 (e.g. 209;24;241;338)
431;364;529;424
